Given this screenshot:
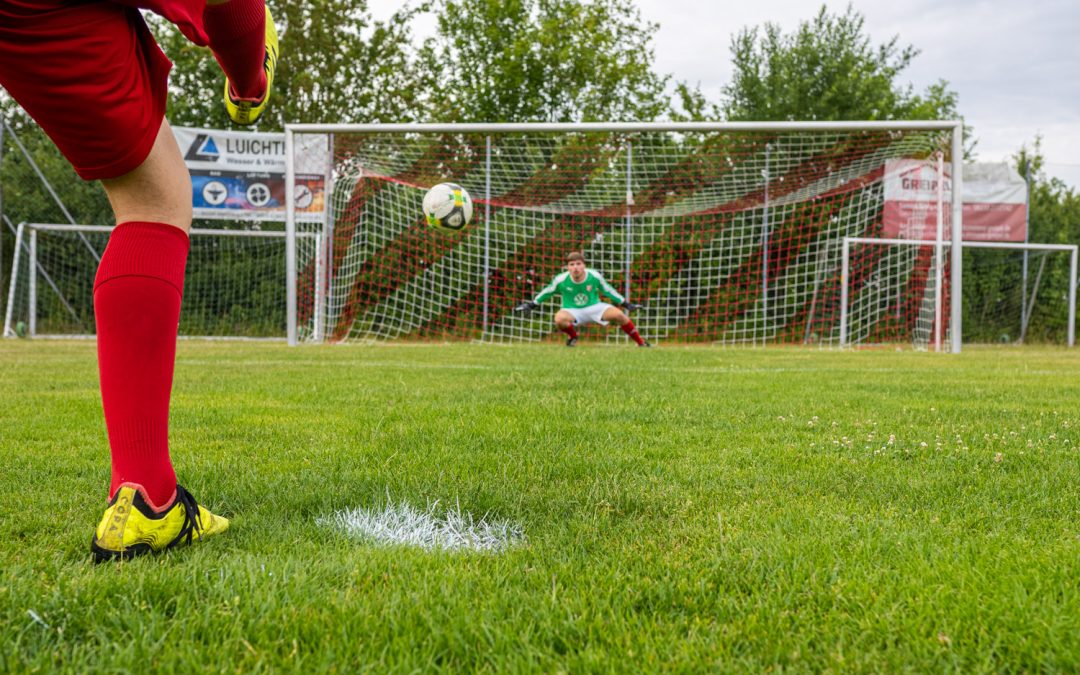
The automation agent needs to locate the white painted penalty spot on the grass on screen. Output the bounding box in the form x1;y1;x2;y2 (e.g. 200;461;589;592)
316;494;525;552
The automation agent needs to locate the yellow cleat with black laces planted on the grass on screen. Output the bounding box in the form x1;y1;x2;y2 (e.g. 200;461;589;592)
90;483;229;563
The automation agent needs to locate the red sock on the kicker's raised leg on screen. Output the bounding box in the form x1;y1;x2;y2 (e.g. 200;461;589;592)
203;0;267;99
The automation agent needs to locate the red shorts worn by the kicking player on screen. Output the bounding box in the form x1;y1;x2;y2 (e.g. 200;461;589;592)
0;0;207;180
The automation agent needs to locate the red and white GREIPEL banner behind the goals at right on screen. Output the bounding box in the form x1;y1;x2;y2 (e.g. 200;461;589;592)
882;160;1027;242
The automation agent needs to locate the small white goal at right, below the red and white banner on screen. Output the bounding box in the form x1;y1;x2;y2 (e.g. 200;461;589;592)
840;237;1077;351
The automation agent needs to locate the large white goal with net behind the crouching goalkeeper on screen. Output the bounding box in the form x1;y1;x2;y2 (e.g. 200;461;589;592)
286;122;976;351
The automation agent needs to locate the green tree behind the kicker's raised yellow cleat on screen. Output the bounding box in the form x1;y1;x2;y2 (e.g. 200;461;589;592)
151;0;427;130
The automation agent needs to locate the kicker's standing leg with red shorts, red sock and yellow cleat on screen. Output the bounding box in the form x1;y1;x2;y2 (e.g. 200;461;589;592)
0;3;228;559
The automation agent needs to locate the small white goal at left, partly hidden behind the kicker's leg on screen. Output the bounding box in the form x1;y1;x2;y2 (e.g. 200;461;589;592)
3;224;320;340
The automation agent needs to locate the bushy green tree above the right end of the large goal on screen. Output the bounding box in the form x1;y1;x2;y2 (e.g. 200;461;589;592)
720;4;957;121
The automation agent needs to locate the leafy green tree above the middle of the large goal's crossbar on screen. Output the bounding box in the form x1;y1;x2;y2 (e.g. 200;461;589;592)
423;0;669;122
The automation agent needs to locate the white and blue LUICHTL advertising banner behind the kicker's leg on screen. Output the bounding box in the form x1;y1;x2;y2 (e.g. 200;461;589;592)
173;126;329;222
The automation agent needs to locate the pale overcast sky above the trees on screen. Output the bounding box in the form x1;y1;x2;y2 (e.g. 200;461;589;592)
370;0;1080;188
